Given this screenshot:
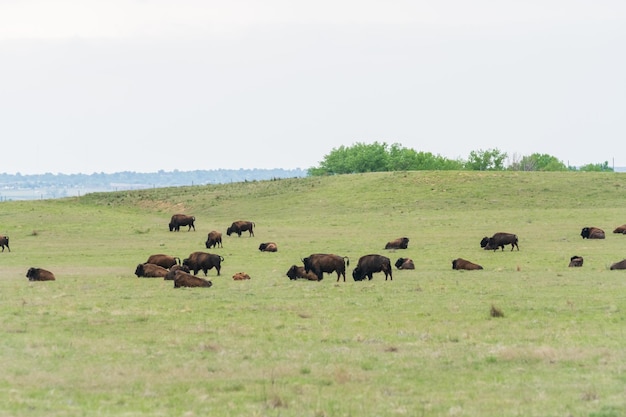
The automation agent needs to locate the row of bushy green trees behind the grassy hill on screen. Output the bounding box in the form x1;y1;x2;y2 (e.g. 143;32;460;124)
307;142;613;176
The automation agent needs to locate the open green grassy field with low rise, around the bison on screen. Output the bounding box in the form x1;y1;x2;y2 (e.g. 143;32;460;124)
0;172;626;417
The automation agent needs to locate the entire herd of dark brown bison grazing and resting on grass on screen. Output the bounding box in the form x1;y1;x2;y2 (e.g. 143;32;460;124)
8;214;626;288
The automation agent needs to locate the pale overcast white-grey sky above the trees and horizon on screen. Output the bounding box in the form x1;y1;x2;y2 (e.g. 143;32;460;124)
0;0;626;174
